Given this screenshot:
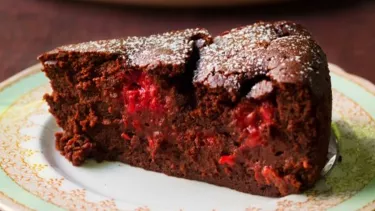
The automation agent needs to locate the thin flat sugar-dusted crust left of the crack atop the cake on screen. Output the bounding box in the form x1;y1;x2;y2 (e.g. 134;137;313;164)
39;28;211;68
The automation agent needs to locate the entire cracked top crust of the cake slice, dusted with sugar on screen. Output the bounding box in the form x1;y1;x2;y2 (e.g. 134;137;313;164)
39;21;330;99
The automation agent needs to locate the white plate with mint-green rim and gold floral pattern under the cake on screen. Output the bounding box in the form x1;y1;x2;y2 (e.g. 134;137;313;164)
0;64;375;211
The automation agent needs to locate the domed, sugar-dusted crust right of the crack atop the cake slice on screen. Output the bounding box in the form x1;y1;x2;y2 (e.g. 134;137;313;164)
194;21;328;95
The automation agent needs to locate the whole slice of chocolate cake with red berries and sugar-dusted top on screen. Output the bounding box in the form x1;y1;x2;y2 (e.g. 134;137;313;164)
39;22;332;196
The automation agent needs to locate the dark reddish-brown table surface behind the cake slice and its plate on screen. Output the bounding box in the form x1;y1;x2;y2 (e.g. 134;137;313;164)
0;0;375;83
